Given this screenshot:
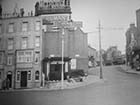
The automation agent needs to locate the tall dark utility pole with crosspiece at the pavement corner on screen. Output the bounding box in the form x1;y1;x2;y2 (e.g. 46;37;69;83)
98;20;103;79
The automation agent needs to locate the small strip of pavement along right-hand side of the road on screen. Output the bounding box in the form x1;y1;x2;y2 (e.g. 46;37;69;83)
120;65;140;74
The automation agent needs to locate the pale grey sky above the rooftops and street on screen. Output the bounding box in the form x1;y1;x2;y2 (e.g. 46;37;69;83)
0;0;140;53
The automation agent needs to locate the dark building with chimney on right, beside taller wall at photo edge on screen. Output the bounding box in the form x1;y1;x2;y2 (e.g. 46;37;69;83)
126;24;140;68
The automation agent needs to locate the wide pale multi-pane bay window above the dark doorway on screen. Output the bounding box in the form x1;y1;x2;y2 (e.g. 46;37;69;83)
17;51;33;63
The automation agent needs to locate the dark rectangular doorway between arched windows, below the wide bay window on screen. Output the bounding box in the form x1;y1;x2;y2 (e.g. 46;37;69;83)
20;71;27;88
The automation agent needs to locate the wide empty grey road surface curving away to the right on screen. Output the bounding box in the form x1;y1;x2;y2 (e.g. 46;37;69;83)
0;66;140;105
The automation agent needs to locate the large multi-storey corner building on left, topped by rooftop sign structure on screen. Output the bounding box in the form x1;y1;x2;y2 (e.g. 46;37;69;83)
0;0;88;88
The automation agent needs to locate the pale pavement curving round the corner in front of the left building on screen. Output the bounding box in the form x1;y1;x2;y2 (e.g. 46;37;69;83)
0;69;104;92
